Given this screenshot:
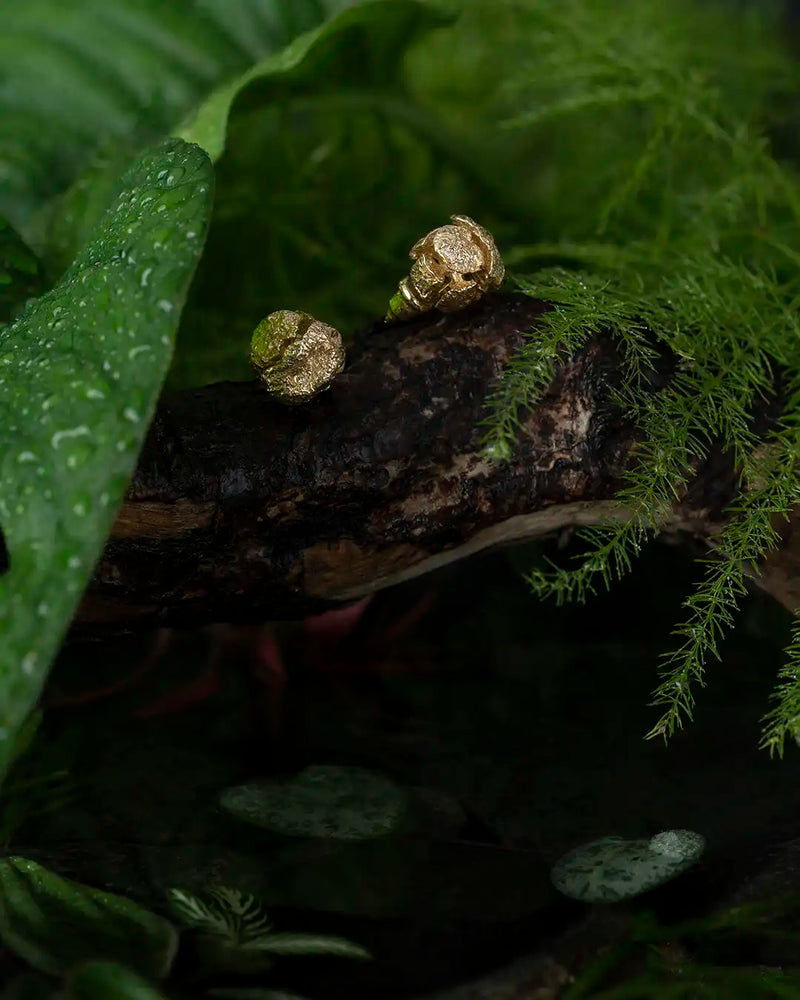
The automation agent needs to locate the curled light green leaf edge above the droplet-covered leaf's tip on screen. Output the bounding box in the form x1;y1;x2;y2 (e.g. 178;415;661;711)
178;0;449;160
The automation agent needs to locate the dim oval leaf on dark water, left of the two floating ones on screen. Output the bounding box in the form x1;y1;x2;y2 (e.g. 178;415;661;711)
220;765;406;840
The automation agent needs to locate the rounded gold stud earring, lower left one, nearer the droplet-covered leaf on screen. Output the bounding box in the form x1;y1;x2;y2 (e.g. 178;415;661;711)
250;309;345;404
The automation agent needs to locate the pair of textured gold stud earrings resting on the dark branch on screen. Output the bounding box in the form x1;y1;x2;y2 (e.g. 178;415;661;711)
250;215;505;404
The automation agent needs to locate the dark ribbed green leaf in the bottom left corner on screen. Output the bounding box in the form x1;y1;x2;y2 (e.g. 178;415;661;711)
0;858;178;976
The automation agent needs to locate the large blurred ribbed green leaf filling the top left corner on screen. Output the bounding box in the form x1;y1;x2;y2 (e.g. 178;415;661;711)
0;0;352;229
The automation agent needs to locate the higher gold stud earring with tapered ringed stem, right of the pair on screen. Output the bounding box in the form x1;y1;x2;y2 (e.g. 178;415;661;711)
386;215;505;320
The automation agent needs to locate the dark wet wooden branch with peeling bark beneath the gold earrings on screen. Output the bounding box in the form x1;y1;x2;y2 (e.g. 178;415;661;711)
75;295;800;631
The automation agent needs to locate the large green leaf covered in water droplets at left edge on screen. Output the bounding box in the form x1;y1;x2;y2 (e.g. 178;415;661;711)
0;140;213;776
